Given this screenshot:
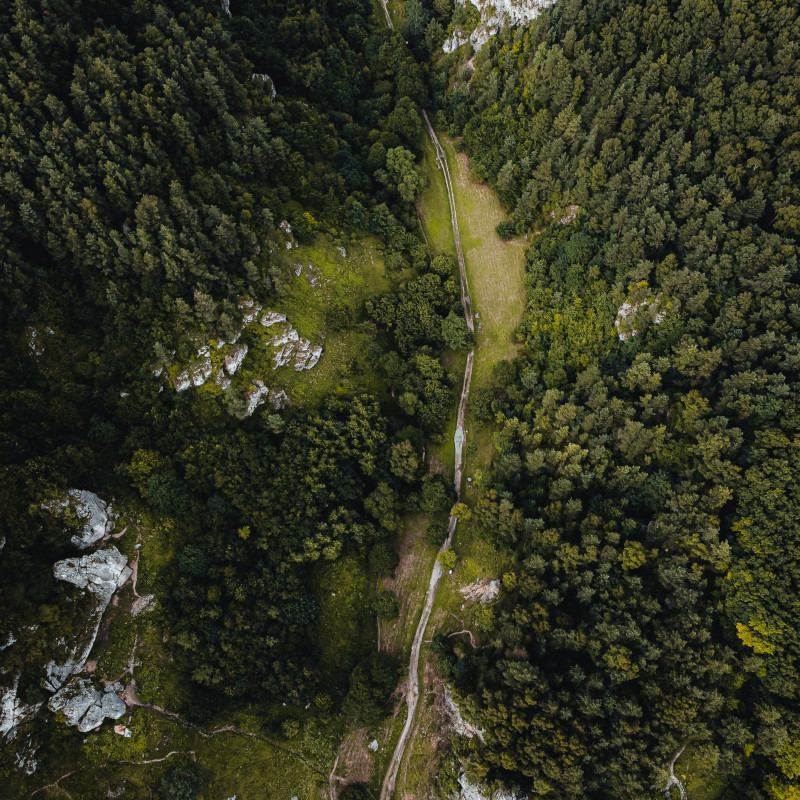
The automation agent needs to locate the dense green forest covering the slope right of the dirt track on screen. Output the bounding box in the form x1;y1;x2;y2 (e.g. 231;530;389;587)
432;0;800;799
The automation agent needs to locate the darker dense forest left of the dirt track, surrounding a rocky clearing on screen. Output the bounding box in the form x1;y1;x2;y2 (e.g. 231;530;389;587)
0;0;460;788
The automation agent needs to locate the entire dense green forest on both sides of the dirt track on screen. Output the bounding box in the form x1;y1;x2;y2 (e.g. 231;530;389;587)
0;0;800;800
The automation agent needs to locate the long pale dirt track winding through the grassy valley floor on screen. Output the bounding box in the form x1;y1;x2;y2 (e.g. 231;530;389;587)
381;119;475;800
